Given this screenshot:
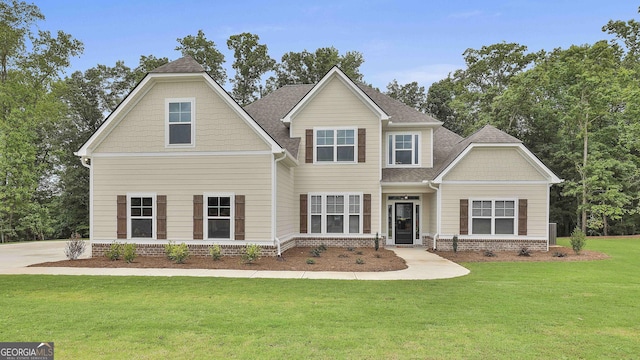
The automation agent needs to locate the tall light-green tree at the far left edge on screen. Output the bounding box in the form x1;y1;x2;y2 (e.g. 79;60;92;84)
0;1;82;242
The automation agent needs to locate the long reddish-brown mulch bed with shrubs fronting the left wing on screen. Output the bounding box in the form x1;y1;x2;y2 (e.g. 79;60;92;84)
31;247;407;272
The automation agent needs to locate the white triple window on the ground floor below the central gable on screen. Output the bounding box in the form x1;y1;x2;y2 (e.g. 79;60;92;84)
309;193;363;234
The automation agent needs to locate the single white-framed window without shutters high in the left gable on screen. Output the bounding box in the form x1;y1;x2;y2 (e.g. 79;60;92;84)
165;98;196;147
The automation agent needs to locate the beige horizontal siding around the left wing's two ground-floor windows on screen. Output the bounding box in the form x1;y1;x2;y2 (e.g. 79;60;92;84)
92;154;273;241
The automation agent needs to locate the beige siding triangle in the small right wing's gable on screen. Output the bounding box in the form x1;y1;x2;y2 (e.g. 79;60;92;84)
444;147;547;181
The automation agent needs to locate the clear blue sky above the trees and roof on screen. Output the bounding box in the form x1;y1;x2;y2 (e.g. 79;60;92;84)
34;0;639;90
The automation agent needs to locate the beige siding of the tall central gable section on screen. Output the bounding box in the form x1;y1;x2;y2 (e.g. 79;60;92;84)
291;77;381;233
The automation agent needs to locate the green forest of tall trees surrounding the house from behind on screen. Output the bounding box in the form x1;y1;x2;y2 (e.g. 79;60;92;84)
0;0;640;242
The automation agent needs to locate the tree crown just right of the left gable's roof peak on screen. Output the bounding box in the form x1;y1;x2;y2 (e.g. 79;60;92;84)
176;30;227;85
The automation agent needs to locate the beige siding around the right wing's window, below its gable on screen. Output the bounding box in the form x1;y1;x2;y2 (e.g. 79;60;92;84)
440;183;548;237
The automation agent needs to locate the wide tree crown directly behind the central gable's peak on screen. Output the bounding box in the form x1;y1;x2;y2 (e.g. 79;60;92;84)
267;46;364;89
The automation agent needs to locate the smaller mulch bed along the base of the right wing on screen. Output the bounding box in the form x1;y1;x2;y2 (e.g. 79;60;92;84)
432;246;609;263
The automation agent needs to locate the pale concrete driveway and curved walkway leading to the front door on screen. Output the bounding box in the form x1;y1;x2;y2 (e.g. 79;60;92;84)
0;241;469;280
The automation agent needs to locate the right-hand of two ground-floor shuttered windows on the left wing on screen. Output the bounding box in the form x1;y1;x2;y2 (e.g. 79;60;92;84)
204;193;235;240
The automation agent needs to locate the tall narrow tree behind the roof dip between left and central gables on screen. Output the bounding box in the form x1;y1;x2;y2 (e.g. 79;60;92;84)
227;33;276;105
